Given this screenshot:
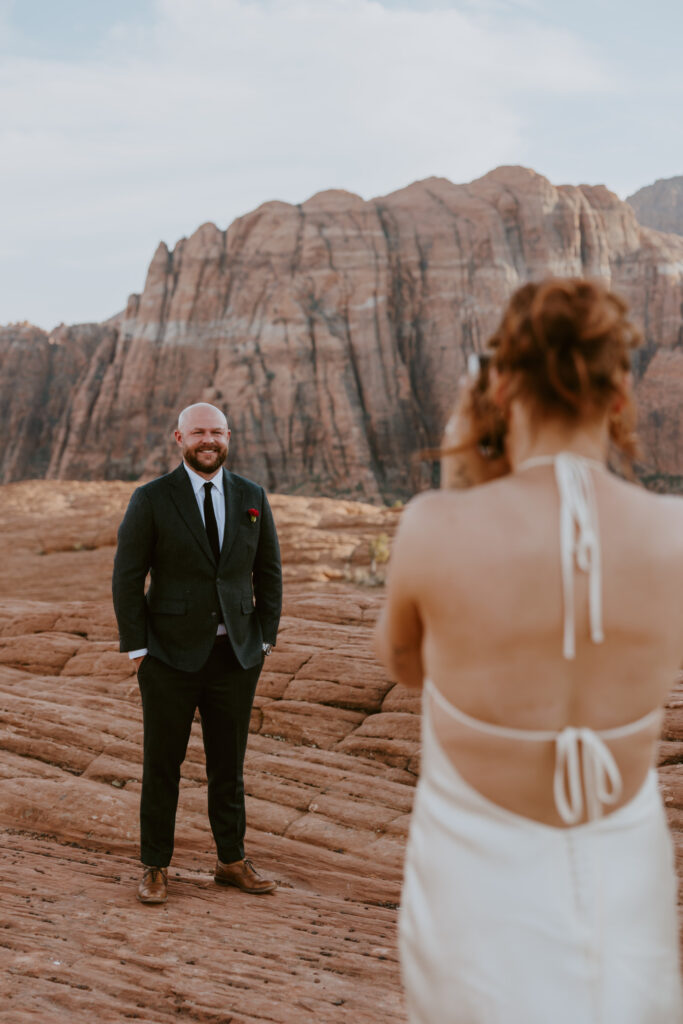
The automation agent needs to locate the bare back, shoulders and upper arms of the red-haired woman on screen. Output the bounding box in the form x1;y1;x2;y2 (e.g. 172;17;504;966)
400;466;683;825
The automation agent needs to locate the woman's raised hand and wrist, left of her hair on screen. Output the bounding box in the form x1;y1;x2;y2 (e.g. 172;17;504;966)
441;377;510;489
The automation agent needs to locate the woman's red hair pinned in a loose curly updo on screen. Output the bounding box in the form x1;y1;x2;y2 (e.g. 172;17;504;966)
490;278;641;458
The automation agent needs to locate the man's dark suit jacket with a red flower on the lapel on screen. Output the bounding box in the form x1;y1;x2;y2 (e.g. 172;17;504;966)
112;464;283;672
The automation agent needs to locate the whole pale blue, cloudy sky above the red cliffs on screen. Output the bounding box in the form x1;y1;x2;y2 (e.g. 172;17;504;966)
0;0;683;330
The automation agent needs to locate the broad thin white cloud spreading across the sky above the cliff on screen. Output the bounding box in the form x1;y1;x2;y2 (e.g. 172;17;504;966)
0;0;613;327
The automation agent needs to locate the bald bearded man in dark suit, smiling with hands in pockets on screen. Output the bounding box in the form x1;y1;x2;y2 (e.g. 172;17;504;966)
113;402;282;903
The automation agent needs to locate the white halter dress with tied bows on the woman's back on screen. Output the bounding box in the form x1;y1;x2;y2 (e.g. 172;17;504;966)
399;453;683;1024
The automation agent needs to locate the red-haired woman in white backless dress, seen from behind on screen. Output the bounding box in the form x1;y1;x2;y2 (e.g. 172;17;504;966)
377;280;683;1024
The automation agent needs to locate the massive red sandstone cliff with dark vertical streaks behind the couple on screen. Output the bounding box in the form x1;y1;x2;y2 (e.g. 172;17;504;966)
0;167;683;501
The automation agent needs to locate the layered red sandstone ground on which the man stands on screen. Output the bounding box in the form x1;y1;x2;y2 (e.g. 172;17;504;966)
0;481;683;1024
